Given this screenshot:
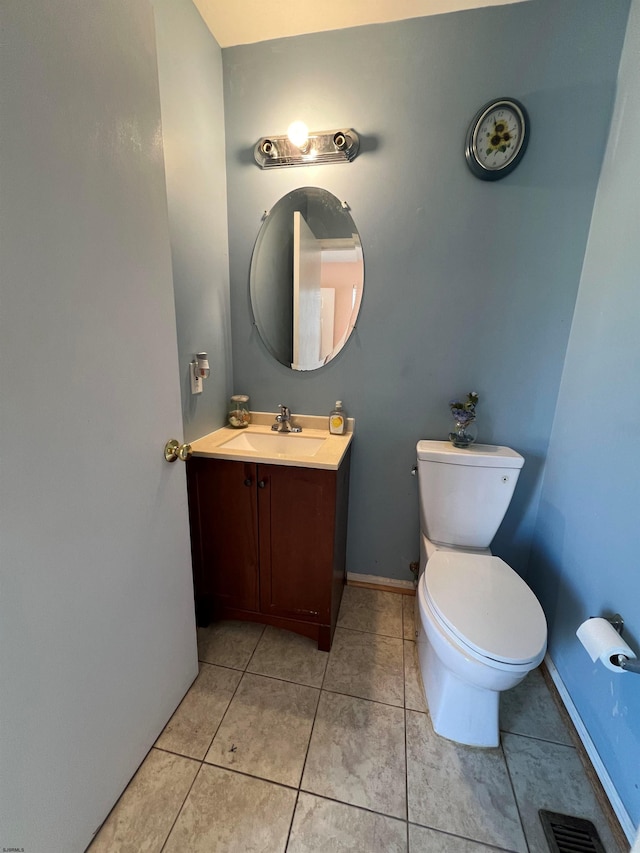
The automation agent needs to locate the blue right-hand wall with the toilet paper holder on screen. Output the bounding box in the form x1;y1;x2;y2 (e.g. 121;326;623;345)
529;0;640;825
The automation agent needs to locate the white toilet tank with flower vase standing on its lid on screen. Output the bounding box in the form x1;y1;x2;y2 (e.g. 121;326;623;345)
416;441;524;548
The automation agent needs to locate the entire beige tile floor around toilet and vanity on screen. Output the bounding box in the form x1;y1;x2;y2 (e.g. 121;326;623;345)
89;587;620;853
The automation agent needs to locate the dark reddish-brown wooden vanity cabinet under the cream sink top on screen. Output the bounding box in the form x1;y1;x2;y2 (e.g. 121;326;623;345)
187;449;350;651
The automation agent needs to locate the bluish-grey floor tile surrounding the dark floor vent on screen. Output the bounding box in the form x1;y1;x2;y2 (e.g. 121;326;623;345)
502;734;619;853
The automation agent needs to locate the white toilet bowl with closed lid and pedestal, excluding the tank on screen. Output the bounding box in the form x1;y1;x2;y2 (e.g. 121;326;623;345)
417;537;547;747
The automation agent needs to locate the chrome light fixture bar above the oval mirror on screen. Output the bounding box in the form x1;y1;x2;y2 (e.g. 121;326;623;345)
253;128;360;169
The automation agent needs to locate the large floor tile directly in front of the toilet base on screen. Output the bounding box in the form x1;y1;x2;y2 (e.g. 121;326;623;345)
407;711;527;853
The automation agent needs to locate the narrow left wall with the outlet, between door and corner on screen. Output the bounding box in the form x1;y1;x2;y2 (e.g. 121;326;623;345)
153;0;231;441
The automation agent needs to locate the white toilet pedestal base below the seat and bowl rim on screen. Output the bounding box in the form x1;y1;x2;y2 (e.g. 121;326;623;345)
418;624;500;747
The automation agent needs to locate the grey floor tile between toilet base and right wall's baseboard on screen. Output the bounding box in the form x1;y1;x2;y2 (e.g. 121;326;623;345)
500;669;573;746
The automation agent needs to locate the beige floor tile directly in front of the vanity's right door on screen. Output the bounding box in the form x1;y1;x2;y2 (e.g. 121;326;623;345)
247;625;329;687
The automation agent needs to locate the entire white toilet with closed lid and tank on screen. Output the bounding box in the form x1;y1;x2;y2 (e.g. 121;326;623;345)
416;441;547;747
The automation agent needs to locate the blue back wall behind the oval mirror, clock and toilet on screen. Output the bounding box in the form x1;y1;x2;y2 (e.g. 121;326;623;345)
223;0;629;579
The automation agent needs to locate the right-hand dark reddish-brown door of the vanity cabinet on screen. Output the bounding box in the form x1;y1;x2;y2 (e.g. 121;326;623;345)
258;465;336;624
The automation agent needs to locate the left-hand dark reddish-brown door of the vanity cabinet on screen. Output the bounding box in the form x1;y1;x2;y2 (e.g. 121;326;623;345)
188;458;259;611
